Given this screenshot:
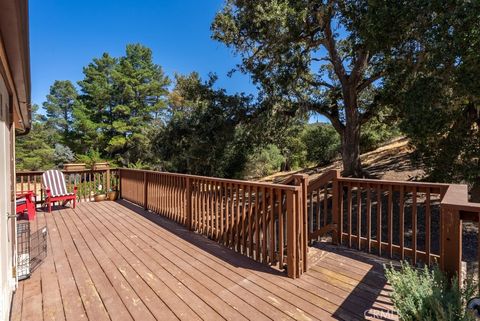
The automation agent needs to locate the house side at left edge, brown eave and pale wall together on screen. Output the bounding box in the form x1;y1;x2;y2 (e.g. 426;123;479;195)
0;0;31;320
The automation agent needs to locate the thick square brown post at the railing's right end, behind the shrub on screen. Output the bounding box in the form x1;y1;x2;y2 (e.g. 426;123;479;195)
440;204;462;284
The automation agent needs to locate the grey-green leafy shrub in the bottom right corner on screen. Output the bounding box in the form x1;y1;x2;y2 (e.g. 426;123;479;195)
385;262;476;321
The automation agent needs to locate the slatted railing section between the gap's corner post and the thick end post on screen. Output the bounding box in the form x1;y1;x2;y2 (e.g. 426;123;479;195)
338;178;448;265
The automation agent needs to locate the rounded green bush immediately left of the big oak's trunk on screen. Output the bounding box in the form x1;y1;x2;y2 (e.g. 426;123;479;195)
302;124;340;165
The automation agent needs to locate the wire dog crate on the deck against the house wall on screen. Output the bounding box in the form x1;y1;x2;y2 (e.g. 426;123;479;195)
17;221;47;280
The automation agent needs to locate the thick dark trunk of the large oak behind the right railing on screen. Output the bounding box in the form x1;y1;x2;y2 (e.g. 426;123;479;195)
341;88;364;177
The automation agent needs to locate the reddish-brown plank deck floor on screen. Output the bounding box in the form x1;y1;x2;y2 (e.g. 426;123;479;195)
11;201;393;321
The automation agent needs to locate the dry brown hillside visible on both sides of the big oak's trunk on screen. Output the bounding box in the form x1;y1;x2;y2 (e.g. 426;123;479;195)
259;137;425;182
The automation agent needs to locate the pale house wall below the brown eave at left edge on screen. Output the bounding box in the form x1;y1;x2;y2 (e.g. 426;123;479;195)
0;72;16;320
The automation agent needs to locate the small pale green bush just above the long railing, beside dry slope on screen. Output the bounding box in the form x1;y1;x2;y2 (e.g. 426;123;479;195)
244;144;285;177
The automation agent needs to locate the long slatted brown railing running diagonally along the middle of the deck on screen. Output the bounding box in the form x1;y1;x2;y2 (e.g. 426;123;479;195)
120;169;307;278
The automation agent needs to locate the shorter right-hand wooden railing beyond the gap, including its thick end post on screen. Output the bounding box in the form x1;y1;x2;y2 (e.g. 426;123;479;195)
307;171;480;277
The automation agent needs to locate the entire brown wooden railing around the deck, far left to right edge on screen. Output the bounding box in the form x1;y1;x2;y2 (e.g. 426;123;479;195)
17;168;480;278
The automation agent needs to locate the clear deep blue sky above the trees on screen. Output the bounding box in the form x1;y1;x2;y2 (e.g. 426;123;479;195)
30;0;326;120
